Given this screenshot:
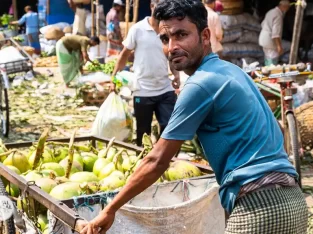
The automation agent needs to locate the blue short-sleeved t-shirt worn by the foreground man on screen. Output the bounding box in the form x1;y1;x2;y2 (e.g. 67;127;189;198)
162;53;298;213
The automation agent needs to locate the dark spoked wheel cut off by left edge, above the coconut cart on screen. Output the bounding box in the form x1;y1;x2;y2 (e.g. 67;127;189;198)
0;85;10;137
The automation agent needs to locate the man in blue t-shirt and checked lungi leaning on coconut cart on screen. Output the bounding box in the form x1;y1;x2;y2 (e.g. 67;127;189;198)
81;0;307;234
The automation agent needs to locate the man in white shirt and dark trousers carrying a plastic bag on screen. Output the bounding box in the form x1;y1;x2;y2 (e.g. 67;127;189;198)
112;0;180;146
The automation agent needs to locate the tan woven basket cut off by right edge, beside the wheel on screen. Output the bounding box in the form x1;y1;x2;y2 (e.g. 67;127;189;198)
295;101;313;149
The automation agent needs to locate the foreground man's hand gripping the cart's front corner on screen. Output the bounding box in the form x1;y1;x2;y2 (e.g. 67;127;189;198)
80;209;115;234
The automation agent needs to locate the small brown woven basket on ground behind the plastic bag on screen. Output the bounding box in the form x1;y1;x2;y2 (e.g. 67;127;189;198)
81;84;110;106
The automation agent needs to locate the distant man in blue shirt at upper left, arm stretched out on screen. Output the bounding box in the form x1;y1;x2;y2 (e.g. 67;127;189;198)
11;6;41;54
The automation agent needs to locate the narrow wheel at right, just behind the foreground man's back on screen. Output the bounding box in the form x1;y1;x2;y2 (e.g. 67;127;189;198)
286;113;302;187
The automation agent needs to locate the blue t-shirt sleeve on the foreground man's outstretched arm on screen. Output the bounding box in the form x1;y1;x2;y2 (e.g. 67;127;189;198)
161;83;213;141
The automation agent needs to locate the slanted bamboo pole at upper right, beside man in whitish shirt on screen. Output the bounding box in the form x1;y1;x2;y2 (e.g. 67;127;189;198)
289;0;306;64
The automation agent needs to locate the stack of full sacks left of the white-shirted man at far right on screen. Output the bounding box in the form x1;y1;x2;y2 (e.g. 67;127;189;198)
220;13;264;66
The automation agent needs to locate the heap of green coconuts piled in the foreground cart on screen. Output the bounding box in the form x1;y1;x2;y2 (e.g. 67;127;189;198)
0;131;202;231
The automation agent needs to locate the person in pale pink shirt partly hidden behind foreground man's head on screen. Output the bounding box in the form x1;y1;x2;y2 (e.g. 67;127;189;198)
205;0;223;55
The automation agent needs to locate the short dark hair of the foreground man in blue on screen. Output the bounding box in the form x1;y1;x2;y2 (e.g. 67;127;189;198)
154;0;208;33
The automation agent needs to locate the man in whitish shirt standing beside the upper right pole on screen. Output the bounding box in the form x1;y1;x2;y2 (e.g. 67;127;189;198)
259;0;290;66
